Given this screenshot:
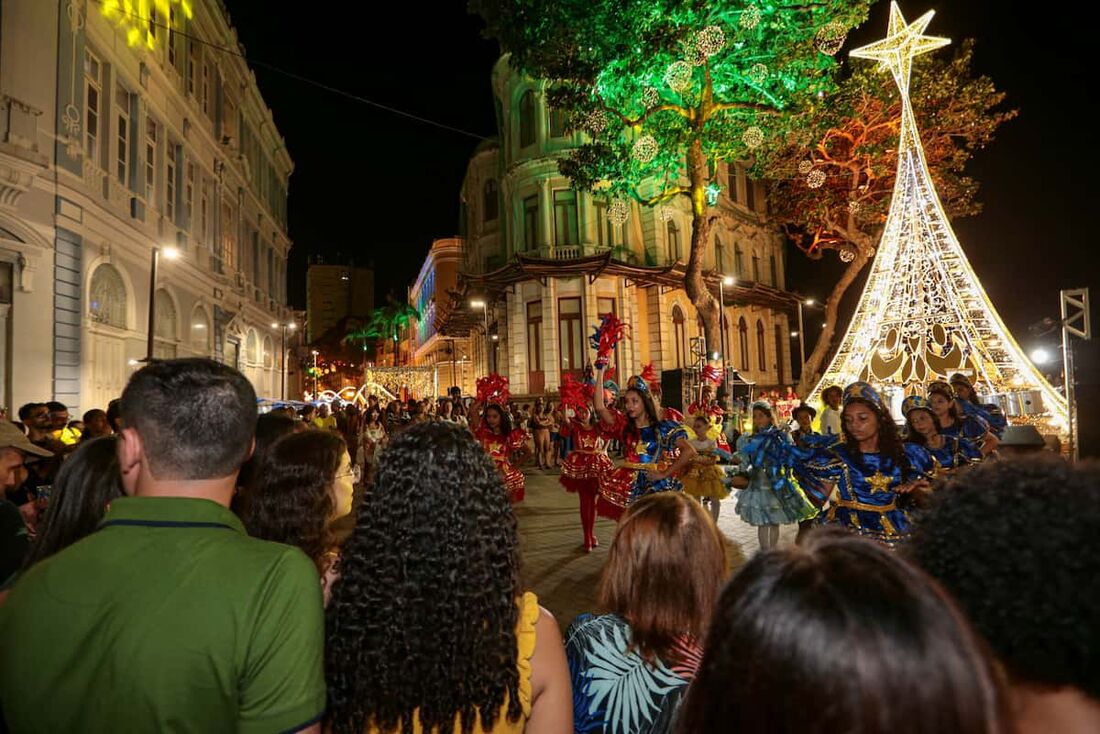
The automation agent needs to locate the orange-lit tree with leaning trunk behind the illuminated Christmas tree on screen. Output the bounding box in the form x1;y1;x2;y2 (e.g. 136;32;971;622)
755;41;1016;395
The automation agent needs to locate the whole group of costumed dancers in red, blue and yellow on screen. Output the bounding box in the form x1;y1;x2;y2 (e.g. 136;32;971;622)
472;317;1007;551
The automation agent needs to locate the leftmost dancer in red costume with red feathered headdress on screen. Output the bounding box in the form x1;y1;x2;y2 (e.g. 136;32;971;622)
470;374;529;503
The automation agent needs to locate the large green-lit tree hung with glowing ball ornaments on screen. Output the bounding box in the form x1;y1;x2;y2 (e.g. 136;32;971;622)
470;0;870;356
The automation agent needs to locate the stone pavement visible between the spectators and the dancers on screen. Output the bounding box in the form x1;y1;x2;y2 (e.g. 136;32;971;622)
516;469;798;629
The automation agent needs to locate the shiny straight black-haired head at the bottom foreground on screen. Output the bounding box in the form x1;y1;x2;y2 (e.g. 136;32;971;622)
681;532;1009;734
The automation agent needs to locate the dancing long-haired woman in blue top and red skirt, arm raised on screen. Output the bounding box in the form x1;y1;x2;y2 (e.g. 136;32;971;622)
592;362;695;519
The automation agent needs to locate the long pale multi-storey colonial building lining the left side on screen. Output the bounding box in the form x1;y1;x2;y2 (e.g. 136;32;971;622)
0;0;293;412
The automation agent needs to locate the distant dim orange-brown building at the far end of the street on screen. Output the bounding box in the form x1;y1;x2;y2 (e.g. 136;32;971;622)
306;258;374;343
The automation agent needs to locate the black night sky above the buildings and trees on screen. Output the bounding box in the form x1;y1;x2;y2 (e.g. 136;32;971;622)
226;0;1100;356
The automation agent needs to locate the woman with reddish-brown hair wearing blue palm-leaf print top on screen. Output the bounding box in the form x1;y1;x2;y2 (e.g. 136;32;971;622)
565;492;726;734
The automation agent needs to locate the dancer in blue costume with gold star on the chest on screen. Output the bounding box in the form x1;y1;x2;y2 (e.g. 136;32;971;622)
745;382;935;546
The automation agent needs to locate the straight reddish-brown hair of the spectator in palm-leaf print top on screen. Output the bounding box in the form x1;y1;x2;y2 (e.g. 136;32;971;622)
600;492;726;664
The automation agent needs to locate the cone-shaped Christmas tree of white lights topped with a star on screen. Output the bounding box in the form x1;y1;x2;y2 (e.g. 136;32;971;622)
811;3;1067;428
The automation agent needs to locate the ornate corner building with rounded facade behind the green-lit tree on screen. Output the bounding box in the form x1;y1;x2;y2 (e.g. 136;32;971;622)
443;57;796;402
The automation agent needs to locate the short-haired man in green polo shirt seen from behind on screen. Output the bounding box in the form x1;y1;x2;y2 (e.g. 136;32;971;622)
0;360;325;732
